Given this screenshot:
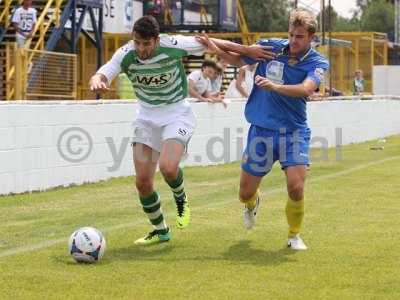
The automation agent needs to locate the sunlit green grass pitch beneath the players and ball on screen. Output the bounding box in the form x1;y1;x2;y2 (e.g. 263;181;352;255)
0;137;400;299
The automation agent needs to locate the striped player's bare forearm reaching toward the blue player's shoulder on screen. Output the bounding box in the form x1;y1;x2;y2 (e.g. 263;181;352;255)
211;38;275;60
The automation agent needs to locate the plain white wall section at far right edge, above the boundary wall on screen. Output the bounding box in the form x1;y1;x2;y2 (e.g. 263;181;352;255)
372;66;400;95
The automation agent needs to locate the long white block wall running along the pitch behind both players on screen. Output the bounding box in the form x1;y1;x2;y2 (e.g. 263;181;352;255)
0;100;400;194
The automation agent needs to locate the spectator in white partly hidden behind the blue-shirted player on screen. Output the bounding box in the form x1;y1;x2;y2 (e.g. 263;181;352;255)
225;64;257;98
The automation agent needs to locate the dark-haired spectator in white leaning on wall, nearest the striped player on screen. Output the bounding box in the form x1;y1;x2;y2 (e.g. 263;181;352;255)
188;60;226;108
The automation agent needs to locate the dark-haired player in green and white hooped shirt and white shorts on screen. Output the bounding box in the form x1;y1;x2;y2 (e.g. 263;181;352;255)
89;16;271;245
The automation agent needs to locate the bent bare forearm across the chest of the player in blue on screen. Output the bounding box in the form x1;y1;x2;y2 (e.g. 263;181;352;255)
254;75;317;97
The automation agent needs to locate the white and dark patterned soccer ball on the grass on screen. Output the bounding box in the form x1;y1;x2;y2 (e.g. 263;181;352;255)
68;227;106;263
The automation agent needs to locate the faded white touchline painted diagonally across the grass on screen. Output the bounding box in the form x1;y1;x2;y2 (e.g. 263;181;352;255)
0;156;400;258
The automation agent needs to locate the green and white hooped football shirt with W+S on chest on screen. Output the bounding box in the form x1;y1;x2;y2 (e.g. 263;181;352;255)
97;35;205;106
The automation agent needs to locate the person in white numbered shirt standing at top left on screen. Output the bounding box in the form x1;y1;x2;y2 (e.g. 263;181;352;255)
11;0;37;48
